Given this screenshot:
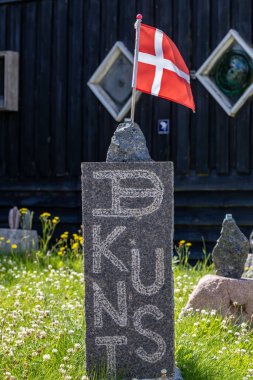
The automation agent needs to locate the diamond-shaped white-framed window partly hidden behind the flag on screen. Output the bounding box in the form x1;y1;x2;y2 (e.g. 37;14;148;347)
88;41;140;121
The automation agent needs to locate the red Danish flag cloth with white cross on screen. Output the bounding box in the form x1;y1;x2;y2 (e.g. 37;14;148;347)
136;24;195;112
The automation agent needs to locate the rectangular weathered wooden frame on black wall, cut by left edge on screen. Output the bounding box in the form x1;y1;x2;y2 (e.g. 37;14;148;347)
0;51;19;111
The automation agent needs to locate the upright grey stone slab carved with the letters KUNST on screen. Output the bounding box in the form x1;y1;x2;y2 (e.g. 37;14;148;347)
82;162;174;379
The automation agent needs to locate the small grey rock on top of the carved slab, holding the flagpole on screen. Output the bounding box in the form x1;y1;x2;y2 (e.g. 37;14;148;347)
106;122;152;162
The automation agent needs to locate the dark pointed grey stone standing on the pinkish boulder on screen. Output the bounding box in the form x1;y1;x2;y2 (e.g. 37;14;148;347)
212;218;250;278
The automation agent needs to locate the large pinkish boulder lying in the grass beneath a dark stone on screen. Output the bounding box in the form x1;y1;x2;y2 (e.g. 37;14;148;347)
180;275;253;321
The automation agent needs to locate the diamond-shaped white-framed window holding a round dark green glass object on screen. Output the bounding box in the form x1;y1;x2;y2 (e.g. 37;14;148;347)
196;29;253;116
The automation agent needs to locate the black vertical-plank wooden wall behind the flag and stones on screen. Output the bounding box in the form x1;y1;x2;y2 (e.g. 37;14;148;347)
0;0;253;255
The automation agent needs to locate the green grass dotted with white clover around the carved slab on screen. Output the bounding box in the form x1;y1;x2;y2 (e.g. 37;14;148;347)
0;257;253;380
